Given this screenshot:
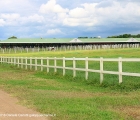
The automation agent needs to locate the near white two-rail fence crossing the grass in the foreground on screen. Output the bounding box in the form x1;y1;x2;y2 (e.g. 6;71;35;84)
0;56;140;83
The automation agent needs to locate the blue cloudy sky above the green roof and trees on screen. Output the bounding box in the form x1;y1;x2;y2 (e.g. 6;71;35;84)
0;0;140;39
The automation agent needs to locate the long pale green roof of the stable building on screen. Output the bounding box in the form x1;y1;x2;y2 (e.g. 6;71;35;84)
0;38;140;43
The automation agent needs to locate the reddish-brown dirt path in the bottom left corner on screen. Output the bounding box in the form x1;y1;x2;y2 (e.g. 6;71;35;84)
0;90;50;120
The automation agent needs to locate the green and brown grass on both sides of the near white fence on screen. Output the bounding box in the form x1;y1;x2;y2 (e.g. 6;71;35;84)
0;49;140;120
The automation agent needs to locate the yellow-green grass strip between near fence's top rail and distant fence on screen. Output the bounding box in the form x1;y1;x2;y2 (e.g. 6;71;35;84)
0;48;140;58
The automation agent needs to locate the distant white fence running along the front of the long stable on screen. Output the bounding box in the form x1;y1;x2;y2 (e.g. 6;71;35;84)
0;44;140;54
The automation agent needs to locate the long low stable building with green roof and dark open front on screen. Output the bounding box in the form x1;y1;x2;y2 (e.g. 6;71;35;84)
0;38;140;48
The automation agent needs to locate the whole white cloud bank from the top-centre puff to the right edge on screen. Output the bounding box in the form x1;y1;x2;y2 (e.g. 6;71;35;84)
39;0;140;27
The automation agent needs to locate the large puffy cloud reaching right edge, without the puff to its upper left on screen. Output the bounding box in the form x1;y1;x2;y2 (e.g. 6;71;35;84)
63;0;140;26
